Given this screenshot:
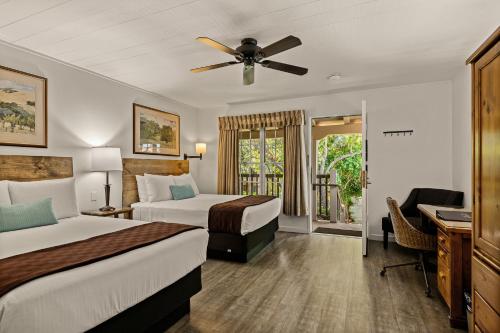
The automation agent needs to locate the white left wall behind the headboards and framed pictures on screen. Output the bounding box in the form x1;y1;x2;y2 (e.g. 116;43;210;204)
0;44;199;209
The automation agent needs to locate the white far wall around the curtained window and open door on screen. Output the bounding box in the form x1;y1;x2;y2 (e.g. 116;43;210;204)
199;81;452;239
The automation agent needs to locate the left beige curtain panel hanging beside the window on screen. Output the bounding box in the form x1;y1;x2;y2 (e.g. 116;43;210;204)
217;129;240;194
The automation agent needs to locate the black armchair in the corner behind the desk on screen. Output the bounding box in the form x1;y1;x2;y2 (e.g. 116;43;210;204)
382;188;464;249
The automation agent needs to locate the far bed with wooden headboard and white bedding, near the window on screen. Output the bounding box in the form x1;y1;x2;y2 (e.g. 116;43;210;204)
122;158;281;262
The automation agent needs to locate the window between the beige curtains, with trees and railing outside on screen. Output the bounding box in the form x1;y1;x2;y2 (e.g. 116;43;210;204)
239;127;284;197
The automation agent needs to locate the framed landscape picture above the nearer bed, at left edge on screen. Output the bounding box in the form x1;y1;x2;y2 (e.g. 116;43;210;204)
0;66;47;148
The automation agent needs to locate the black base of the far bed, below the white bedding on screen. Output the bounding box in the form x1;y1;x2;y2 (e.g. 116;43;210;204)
207;217;278;262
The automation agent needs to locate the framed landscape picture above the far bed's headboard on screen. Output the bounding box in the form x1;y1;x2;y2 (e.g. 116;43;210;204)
134;103;181;156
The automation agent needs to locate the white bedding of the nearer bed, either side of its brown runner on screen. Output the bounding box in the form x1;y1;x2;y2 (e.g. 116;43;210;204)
0;216;208;333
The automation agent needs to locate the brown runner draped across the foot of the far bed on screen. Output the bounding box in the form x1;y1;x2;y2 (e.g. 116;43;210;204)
208;195;275;235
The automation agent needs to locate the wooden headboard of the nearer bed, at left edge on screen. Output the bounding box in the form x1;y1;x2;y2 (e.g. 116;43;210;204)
0;155;73;182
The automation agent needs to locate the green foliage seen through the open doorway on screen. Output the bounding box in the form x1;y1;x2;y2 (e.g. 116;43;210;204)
317;134;362;219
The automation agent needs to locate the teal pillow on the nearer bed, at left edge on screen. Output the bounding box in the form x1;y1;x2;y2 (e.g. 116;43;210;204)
0;198;57;232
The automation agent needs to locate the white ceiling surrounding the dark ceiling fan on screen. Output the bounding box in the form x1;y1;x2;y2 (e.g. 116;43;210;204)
0;0;500;107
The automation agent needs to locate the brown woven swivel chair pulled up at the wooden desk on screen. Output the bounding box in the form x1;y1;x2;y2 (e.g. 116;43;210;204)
380;197;436;296
